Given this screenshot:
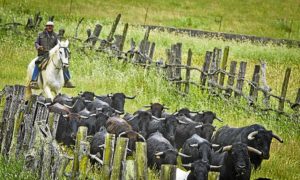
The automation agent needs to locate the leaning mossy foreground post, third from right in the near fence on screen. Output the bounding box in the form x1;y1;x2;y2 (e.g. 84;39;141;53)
110;137;128;180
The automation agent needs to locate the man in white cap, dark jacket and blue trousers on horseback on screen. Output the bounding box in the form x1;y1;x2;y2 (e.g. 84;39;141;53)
30;21;75;89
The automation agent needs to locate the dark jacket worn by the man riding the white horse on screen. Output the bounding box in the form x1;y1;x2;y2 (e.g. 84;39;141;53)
35;29;58;56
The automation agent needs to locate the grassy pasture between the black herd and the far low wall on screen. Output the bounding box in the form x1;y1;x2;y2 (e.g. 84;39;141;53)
0;1;300;179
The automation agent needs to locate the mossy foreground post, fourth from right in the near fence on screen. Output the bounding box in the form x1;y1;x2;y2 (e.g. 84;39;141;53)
103;133;115;179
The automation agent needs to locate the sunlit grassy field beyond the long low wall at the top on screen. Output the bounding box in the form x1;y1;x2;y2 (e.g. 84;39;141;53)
1;0;300;39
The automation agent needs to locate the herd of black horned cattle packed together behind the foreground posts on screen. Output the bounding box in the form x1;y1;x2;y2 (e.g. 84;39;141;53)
45;92;283;179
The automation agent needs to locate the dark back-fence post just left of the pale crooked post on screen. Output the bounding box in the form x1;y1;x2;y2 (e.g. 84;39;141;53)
249;65;260;105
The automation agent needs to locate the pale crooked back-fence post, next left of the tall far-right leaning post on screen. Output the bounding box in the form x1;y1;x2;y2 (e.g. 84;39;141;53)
261;61;271;108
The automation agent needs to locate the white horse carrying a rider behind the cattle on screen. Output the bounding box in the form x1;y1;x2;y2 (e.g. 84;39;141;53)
26;40;70;100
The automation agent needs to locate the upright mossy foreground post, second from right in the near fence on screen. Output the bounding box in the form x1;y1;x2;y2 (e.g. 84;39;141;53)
135;142;148;180
